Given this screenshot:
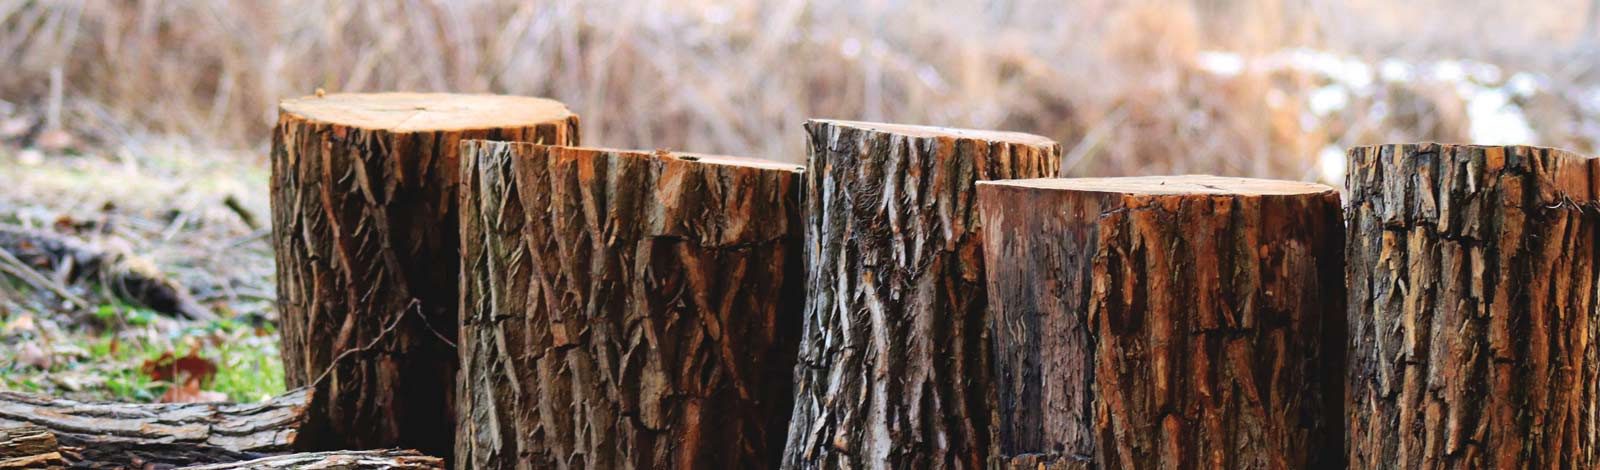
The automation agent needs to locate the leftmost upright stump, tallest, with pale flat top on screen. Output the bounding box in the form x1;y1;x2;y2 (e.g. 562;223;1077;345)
272;93;578;456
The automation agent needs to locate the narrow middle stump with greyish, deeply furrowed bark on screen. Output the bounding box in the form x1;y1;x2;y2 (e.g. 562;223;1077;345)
782;120;1061;468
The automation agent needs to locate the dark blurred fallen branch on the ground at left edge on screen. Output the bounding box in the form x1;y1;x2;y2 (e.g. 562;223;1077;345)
0;225;216;320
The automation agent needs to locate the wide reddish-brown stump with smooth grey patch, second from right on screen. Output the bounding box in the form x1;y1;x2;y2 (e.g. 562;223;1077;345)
978;176;1346;468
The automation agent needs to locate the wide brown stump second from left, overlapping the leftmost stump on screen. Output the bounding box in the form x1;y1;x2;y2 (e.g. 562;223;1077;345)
454;142;805;468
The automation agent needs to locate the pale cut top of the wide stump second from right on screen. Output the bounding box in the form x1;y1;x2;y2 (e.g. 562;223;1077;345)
978;174;1333;195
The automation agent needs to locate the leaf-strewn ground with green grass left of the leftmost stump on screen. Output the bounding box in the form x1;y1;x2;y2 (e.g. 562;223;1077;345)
0;134;283;401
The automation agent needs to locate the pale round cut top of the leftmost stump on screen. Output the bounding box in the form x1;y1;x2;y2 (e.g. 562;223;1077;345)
278;93;573;133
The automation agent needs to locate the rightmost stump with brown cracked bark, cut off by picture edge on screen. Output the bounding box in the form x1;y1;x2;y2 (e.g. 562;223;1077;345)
1346;144;1600;468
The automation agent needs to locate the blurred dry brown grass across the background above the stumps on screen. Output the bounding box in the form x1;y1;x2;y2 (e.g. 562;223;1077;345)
0;0;1595;179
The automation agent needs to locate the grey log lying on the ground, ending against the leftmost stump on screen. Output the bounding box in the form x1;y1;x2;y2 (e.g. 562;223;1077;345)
0;390;307;468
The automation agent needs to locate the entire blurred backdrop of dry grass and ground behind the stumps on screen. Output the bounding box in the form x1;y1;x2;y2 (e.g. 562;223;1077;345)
0;0;1600;400
